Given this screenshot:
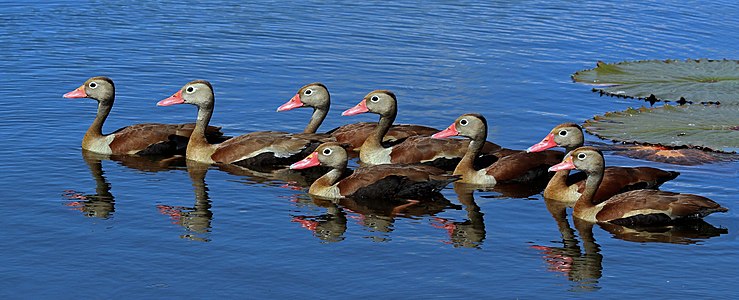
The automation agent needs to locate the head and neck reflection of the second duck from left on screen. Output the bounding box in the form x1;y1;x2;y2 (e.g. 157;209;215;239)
157;160;213;242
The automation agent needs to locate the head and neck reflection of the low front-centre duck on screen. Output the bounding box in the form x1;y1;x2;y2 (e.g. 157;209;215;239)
292;194;347;243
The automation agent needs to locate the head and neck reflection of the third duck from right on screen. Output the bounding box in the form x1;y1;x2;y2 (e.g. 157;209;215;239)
432;182;485;248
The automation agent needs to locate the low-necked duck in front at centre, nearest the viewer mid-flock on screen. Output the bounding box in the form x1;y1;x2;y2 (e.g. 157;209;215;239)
290;142;457;201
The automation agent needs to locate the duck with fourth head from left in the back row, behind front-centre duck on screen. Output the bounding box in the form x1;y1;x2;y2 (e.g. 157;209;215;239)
342;90;501;170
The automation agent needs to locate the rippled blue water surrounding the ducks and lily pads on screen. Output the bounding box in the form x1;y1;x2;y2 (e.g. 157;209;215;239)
0;0;739;299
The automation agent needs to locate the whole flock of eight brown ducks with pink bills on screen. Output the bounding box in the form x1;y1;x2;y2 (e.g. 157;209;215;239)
64;76;728;226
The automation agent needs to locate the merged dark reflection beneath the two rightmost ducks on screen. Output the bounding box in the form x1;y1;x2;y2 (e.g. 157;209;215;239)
532;199;728;290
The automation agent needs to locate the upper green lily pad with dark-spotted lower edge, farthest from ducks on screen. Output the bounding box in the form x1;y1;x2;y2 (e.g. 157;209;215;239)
572;59;739;105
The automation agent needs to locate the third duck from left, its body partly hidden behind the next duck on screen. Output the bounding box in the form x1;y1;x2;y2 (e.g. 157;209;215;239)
277;82;439;151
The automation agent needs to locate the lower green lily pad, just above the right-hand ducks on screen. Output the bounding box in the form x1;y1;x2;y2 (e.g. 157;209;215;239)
583;105;739;153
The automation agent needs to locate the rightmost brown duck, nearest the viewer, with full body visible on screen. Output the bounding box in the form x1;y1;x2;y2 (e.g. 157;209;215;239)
549;147;728;226
